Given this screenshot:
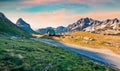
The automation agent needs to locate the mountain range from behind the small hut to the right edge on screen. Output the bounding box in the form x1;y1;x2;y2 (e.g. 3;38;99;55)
37;18;120;35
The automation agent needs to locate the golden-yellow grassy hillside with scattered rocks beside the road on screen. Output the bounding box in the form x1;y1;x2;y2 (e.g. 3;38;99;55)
53;32;120;54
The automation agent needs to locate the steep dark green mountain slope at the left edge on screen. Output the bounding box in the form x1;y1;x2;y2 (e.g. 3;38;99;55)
0;12;27;35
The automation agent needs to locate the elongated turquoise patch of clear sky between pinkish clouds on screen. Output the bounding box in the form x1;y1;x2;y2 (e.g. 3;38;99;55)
23;3;92;13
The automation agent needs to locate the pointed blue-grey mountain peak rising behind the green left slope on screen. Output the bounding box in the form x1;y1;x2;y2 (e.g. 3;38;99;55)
16;18;35;33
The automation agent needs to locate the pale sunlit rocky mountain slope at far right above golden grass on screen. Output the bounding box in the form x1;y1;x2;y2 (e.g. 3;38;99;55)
84;18;120;34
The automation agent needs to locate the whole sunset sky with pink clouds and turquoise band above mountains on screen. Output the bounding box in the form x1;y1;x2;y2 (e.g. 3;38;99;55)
0;0;120;30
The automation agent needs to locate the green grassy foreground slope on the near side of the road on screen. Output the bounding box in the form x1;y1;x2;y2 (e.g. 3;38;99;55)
0;35;115;71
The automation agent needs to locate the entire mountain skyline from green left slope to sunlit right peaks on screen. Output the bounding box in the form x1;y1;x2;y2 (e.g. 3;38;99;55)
0;12;120;35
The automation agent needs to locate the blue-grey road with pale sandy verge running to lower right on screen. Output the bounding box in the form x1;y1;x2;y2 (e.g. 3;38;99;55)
31;38;120;71
